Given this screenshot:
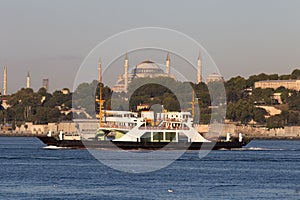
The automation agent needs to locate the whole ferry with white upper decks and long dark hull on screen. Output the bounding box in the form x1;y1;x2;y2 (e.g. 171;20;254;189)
39;111;248;150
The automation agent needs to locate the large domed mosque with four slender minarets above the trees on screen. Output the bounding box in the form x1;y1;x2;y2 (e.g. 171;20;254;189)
102;53;202;92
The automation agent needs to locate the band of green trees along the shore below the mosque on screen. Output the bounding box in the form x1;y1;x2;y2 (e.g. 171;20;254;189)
0;69;300;128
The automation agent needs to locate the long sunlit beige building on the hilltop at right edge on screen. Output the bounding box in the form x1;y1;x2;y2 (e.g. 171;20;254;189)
254;80;300;91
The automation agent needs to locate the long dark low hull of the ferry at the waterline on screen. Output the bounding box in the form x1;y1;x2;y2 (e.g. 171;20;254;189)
38;136;250;150
